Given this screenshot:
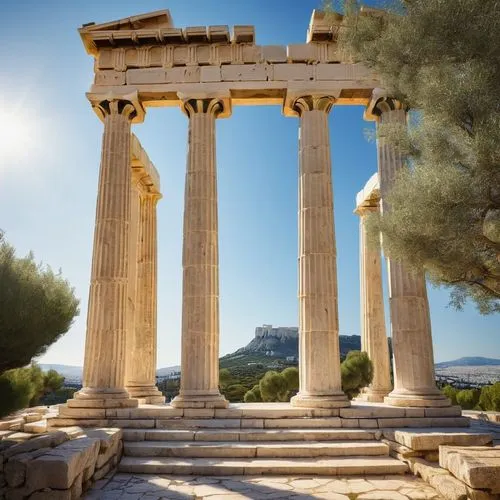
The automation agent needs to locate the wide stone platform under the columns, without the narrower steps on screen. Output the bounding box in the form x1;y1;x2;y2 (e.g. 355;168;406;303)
50;401;469;429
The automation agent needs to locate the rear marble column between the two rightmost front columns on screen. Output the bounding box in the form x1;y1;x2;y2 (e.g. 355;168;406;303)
355;201;392;402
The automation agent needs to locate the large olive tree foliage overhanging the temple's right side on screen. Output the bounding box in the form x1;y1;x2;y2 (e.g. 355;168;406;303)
324;0;500;314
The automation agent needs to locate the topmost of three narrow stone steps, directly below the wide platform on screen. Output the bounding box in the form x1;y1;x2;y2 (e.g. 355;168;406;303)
123;429;381;442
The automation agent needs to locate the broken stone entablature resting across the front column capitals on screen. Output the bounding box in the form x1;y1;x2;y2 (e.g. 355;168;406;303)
80;11;380;106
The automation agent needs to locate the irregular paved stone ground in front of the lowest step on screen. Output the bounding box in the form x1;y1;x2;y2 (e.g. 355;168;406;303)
84;474;442;500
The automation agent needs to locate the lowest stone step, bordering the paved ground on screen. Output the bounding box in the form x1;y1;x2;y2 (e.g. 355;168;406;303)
118;456;408;476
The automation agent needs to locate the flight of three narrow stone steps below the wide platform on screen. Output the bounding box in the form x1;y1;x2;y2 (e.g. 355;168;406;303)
119;426;407;476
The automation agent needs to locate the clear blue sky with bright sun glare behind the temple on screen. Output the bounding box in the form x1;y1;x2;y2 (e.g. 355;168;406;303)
0;0;500;366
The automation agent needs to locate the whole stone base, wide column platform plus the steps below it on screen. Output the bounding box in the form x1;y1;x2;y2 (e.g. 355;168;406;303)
50;401;484;476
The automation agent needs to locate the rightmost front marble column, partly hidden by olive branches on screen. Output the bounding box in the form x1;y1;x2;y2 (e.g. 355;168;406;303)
370;93;450;407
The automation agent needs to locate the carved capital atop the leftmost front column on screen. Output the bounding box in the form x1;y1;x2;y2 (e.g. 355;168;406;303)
87;91;146;123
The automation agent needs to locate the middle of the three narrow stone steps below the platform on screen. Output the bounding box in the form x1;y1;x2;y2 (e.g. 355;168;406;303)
124;441;389;458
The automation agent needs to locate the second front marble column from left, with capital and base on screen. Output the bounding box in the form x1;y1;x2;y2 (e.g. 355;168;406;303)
172;98;228;408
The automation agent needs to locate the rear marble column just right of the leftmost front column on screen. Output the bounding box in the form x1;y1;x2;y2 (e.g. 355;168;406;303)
126;177;165;404
